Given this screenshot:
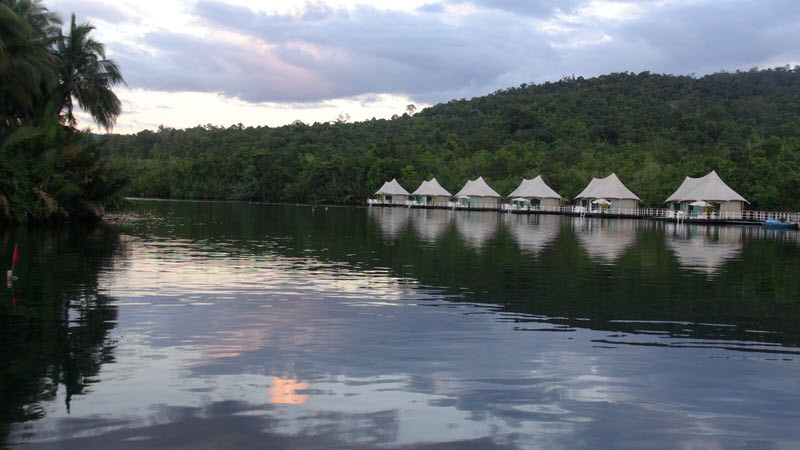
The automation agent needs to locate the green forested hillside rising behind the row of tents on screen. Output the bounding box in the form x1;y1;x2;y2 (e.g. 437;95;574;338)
104;67;800;210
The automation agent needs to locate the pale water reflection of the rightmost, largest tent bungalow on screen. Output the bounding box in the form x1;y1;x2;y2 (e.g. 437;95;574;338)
664;223;744;275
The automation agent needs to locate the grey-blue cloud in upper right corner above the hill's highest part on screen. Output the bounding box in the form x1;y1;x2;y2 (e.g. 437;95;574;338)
565;0;800;81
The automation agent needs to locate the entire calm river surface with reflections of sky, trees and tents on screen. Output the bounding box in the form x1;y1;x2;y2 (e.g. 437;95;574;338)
0;201;800;448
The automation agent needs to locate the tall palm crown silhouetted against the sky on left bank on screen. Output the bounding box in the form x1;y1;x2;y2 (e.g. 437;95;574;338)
54;14;125;130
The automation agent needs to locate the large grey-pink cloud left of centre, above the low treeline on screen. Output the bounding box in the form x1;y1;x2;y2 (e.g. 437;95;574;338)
117;3;550;101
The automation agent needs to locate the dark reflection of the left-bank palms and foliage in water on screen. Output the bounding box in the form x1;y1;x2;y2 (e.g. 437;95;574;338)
0;227;120;440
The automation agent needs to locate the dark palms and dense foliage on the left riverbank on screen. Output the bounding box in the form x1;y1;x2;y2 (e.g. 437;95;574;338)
0;0;124;225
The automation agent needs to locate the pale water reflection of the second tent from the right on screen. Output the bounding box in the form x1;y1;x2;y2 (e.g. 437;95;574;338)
572;217;641;264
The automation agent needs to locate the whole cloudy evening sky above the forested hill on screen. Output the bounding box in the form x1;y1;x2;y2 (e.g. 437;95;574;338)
44;0;800;133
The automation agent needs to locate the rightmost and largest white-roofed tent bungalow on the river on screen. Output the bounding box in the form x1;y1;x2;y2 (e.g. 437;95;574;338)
665;170;750;219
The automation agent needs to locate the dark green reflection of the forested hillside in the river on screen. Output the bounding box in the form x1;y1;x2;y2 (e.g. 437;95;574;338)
115;202;800;344
